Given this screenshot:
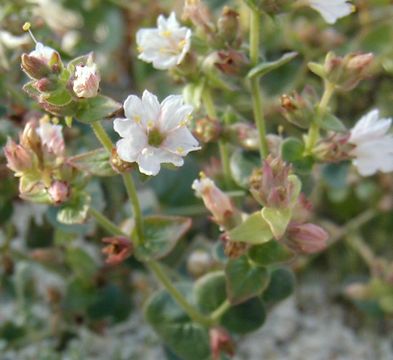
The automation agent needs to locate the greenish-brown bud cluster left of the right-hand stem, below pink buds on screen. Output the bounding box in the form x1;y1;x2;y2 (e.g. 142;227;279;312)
281;86;318;129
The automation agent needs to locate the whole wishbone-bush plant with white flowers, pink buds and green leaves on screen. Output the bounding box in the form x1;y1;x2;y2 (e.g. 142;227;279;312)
4;0;393;360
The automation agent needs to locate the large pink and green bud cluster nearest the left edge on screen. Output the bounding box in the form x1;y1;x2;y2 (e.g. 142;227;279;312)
4;118;73;205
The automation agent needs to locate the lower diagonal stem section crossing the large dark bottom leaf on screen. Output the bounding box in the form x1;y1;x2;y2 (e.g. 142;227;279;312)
145;260;213;326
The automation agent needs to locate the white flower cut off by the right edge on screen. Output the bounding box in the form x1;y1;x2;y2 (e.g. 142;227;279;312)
348;110;393;176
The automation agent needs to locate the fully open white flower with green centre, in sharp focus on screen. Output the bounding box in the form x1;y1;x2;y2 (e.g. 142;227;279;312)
114;90;200;175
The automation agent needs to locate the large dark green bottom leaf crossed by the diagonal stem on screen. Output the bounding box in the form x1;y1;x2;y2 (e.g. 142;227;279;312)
144;284;210;360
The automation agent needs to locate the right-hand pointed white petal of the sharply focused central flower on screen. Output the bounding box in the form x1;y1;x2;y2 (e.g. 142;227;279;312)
161;126;200;156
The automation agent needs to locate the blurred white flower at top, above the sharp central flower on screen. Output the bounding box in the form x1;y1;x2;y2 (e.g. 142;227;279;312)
136;12;191;70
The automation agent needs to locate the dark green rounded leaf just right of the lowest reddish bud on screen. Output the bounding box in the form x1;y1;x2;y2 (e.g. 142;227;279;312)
221;298;266;334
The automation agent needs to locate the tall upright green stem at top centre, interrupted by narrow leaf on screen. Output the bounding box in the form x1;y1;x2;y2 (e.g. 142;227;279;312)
250;9;269;159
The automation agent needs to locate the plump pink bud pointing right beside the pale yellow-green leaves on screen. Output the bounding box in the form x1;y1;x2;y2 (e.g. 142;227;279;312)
287;223;329;254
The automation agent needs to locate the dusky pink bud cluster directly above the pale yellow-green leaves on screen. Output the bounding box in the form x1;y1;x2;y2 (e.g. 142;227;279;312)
250;155;296;209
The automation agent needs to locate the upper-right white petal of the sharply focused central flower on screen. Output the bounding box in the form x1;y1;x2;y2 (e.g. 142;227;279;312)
160;95;193;132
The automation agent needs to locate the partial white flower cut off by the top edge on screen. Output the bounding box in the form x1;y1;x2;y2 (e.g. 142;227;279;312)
309;0;355;24
